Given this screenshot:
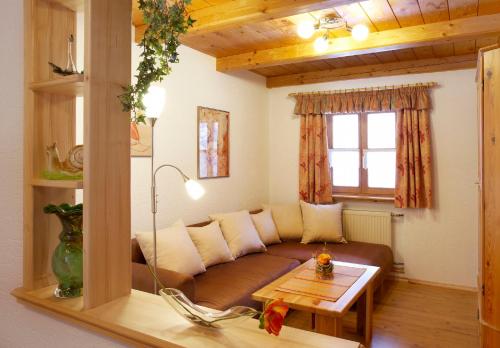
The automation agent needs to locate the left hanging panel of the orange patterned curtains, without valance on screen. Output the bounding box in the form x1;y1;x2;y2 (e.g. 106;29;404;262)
299;114;333;204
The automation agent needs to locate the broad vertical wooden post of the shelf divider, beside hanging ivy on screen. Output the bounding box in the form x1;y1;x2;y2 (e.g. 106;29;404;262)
84;0;131;308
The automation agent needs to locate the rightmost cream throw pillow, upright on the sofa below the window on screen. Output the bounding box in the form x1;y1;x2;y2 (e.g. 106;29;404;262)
300;201;346;244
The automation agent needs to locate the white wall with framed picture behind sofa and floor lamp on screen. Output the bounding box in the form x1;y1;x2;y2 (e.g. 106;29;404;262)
132;45;268;231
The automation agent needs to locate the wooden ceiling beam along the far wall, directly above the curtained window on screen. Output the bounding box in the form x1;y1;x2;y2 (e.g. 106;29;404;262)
267;54;477;88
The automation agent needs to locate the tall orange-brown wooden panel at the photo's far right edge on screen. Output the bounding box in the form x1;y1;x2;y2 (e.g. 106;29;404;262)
479;48;500;347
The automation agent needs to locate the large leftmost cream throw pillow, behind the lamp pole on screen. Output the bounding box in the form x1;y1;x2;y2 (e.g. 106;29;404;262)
135;220;206;276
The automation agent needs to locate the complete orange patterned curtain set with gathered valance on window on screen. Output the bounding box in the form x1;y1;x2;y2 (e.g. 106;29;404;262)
295;86;432;208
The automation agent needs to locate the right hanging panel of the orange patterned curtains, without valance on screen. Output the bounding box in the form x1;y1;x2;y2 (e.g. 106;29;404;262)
394;109;432;208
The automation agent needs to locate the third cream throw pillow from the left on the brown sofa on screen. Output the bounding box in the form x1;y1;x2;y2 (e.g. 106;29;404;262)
210;210;266;259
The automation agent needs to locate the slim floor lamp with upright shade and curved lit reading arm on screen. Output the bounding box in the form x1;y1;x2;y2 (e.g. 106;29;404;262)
143;86;205;294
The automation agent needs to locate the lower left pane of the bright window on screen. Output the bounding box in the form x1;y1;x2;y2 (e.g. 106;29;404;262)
330;150;359;187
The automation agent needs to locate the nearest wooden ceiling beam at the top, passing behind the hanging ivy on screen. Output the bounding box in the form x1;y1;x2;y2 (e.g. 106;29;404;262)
133;0;361;42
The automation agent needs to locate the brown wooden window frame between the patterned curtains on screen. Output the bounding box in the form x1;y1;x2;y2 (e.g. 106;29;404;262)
327;111;396;198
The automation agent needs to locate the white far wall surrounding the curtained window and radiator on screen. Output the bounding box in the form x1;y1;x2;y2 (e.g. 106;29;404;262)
269;70;478;287
